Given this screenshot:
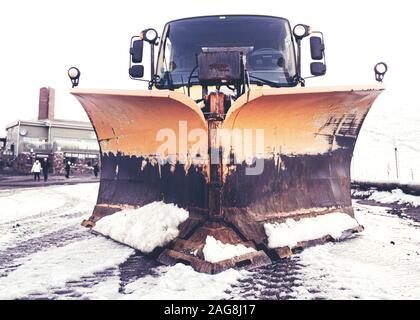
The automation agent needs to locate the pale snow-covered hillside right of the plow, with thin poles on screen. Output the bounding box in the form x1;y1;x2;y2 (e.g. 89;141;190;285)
352;99;420;184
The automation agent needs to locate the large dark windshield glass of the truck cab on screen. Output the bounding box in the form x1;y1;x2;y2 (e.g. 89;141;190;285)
157;16;296;88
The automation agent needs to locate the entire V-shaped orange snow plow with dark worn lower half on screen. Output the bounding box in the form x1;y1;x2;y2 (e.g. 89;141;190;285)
72;86;383;273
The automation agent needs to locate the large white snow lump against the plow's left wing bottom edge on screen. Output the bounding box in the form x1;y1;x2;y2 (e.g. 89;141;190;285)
93;202;188;253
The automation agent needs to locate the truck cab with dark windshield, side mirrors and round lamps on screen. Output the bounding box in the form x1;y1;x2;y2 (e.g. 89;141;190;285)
129;15;326;99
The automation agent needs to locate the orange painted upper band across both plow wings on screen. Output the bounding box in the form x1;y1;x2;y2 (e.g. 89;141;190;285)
71;86;384;161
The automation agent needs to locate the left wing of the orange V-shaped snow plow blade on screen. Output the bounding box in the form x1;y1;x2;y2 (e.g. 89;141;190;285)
72;90;210;220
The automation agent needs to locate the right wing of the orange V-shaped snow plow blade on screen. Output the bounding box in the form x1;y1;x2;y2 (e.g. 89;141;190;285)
223;86;383;243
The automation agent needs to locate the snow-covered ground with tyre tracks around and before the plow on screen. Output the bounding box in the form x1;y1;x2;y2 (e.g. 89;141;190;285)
0;184;420;299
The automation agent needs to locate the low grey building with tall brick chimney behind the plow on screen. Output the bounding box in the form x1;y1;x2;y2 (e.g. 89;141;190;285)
2;88;99;174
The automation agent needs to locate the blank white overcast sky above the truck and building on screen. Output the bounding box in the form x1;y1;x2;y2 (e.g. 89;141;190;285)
0;0;420;132
